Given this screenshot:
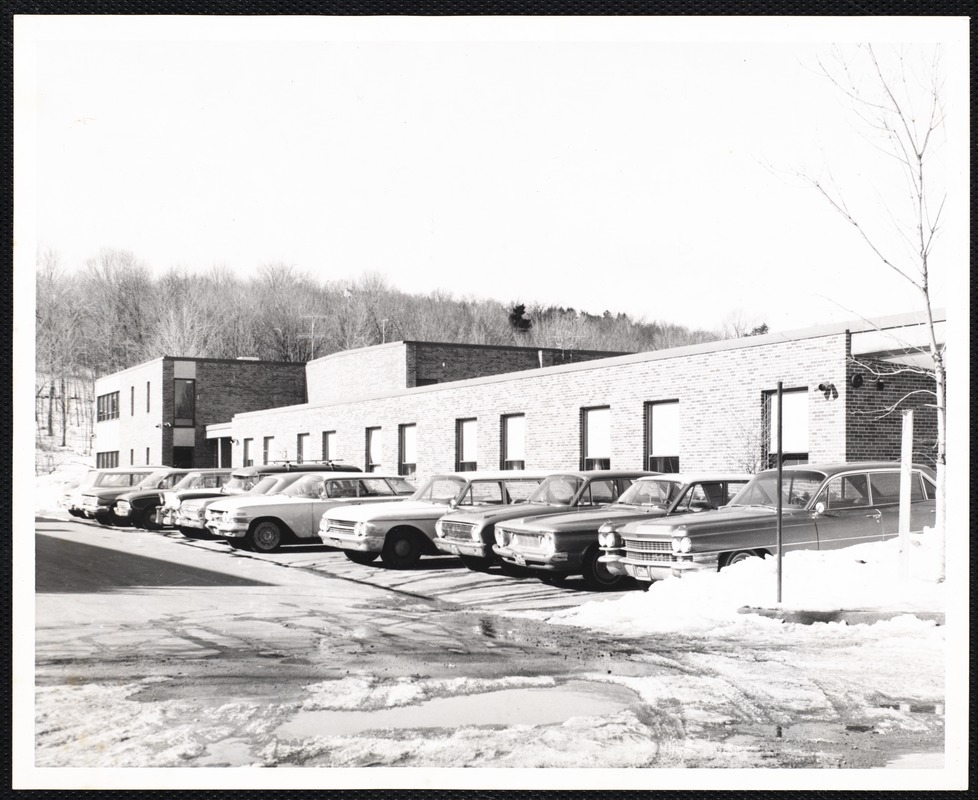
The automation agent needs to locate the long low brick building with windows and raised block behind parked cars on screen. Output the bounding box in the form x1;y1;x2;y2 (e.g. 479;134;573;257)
208;316;943;479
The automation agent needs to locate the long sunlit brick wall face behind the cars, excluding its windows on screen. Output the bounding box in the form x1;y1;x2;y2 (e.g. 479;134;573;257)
232;333;860;480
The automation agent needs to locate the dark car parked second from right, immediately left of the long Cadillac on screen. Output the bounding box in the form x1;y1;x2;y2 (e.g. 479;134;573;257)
493;473;751;589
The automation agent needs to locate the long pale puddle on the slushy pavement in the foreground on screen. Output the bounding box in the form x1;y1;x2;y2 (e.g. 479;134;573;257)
276;681;639;739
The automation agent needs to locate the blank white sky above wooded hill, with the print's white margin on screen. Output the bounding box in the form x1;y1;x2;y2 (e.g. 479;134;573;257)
16;17;968;329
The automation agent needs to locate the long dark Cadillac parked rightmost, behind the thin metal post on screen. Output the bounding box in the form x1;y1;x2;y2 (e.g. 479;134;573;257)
601;462;935;582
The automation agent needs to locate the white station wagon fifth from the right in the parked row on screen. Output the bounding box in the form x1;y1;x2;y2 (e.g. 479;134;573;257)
207;472;415;553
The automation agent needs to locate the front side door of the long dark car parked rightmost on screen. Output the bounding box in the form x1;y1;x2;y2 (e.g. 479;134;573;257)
815;472;883;550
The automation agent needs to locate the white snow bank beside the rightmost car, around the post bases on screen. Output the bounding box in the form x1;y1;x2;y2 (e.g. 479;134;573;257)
550;530;945;635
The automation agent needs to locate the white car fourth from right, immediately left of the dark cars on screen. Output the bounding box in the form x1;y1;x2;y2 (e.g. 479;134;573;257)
319;470;547;569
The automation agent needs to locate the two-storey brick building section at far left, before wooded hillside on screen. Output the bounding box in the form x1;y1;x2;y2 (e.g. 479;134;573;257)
92;356;307;467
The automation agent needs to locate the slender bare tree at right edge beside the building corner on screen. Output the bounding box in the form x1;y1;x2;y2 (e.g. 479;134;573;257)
803;45;947;580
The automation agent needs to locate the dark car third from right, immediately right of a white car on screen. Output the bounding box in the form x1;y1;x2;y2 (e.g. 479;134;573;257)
435;470;652;571
